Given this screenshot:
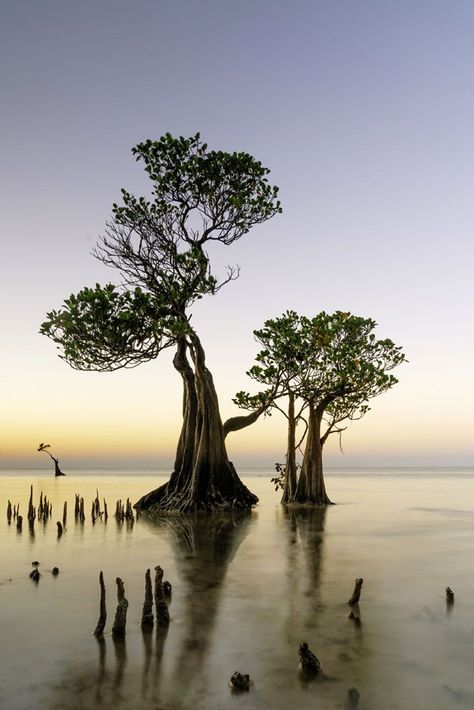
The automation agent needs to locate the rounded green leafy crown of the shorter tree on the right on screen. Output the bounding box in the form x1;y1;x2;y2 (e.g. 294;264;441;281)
234;311;405;434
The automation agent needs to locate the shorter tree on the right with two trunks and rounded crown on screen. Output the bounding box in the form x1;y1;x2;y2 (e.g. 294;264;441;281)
235;311;405;505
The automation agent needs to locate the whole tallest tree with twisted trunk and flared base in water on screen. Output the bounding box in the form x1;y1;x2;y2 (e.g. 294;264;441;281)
40;134;281;511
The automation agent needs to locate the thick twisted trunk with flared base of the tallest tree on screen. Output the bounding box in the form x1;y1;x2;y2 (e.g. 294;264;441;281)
135;333;258;512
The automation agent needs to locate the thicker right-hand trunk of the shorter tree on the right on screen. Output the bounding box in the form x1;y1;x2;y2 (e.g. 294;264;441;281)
294;402;331;505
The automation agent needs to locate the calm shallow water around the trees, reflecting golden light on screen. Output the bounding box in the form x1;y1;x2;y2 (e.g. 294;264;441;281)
0;470;474;710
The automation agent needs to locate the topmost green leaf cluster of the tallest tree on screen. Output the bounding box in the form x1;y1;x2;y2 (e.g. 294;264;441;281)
113;133;281;244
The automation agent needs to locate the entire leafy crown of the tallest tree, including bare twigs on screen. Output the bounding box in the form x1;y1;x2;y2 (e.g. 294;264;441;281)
40;133;281;370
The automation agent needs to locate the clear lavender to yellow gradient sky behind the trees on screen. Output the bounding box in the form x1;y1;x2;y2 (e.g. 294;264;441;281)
0;0;474;470
